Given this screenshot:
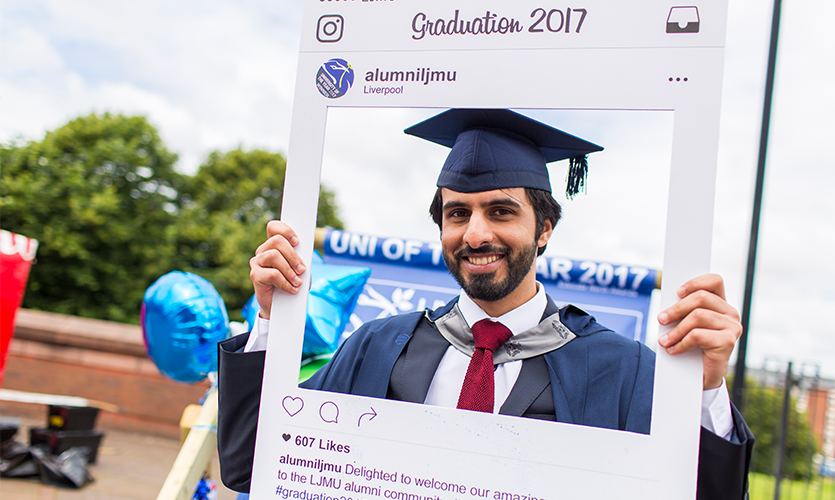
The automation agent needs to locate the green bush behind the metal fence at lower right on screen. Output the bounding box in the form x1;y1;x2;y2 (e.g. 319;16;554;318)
740;379;818;479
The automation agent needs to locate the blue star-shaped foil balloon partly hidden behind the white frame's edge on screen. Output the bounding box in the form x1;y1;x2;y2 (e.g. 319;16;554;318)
242;252;371;359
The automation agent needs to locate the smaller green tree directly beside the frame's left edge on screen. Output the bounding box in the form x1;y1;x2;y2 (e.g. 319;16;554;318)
177;149;343;319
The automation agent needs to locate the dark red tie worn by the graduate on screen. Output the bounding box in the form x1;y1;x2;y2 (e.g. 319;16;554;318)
458;319;513;413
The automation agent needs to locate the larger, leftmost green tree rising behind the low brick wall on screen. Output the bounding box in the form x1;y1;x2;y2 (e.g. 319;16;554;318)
0;114;183;322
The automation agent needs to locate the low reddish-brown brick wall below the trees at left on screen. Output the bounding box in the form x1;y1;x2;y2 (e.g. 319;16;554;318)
0;309;209;437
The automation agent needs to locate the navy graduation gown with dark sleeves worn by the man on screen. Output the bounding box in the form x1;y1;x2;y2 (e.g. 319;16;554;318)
218;297;753;499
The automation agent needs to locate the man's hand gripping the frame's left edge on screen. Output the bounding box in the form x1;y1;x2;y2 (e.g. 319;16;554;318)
249;220;307;319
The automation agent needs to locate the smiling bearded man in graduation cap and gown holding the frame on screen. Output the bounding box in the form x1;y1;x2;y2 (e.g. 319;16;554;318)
218;110;753;499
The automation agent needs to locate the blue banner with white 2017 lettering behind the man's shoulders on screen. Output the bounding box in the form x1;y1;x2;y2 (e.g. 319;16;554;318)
323;230;660;342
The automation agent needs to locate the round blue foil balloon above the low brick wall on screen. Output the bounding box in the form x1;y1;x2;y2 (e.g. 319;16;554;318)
141;271;229;383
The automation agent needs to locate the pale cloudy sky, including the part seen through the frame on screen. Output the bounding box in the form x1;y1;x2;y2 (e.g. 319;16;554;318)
0;0;835;378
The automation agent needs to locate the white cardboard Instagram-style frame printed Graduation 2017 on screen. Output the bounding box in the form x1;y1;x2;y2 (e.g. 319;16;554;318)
251;0;727;499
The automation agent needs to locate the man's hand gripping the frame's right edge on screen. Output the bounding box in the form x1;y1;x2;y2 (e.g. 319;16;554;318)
658;274;742;390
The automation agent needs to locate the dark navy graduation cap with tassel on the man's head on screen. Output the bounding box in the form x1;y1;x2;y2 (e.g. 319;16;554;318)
404;109;603;199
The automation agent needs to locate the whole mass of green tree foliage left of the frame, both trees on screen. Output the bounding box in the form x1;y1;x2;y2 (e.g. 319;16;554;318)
0;114;342;323
